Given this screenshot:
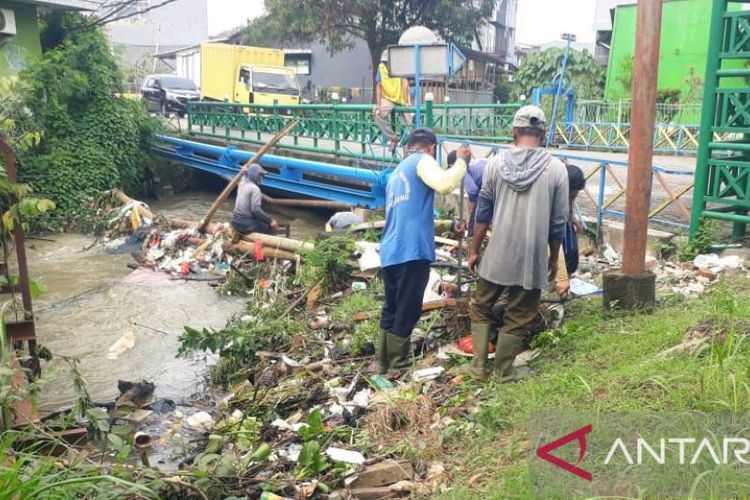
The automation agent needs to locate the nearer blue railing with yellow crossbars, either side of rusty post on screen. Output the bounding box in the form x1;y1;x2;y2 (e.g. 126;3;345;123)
440;137;694;235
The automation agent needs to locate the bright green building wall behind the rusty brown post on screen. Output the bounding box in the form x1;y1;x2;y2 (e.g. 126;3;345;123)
605;0;739;100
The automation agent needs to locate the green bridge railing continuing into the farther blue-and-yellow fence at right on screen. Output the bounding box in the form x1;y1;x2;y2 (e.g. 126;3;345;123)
186;101;728;158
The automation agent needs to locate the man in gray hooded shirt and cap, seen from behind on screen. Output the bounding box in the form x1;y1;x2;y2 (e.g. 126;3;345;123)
467;106;568;381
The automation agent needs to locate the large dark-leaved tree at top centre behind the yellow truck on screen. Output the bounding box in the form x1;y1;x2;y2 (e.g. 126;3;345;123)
243;0;495;84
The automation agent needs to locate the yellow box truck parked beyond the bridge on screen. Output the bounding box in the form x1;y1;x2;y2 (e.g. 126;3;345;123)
177;43;300;105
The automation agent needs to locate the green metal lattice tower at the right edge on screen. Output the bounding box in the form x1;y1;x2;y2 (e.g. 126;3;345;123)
690;0;750;237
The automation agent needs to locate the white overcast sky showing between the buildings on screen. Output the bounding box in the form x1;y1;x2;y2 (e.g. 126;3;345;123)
208;0;596;45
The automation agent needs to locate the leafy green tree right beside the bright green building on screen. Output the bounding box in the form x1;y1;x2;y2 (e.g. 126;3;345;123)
514;48;604;99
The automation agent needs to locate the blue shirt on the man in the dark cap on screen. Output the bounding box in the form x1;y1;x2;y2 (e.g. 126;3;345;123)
380;153;435;267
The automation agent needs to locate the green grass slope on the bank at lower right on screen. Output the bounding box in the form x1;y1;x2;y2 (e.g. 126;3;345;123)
443;279;750;498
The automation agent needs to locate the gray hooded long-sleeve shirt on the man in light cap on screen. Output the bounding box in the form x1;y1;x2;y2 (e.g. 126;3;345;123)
476;147;568;290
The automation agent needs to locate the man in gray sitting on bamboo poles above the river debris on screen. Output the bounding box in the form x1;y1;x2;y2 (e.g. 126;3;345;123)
232;163;279;235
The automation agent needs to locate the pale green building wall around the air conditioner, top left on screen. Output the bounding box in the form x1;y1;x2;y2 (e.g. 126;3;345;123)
0;0;42;77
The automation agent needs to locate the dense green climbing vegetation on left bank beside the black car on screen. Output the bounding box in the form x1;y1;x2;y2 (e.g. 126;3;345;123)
13;12;157;227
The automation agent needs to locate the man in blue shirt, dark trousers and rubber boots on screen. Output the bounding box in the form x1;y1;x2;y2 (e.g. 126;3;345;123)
378;128;466;373
